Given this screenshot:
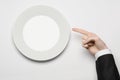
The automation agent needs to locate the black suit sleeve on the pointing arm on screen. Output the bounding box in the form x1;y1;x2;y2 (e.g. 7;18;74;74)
96;54;120;80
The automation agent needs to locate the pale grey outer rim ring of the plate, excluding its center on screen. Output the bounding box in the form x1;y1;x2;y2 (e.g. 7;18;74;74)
13;6;70;61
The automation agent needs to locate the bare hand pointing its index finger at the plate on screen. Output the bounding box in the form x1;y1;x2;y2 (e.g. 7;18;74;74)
72;28;107;55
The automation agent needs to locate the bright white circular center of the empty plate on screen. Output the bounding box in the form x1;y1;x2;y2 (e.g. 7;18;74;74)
23;15;60;51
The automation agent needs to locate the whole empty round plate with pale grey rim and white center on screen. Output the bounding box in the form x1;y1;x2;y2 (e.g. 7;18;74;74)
13;6;70;61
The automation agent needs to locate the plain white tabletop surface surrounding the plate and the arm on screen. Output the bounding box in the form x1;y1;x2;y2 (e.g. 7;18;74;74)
0;0;120;80
